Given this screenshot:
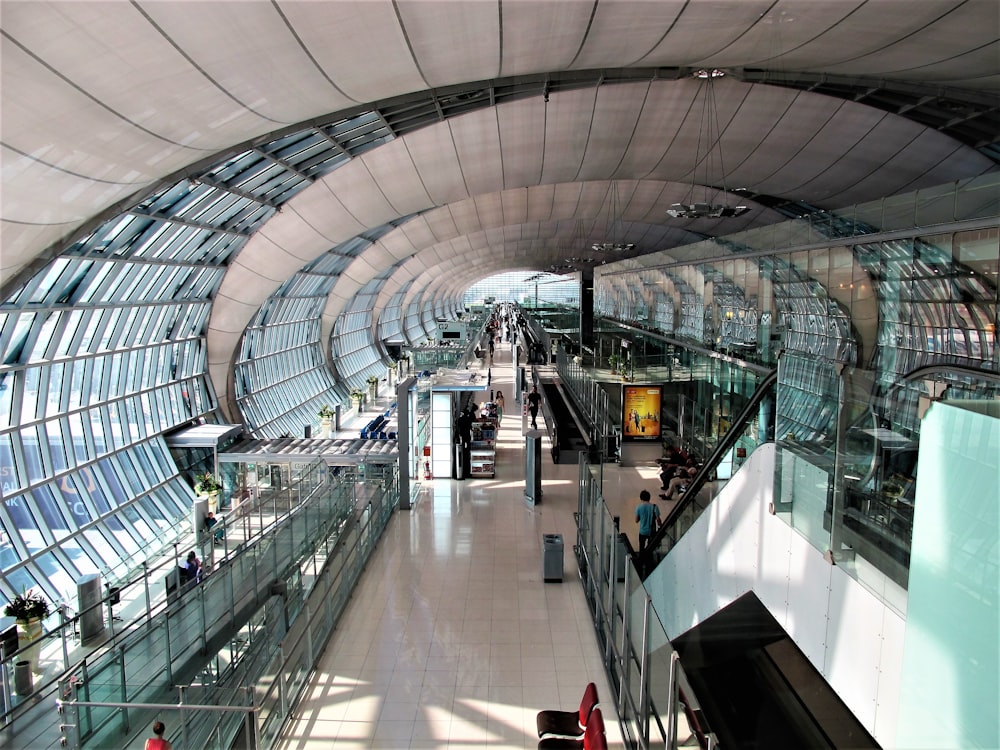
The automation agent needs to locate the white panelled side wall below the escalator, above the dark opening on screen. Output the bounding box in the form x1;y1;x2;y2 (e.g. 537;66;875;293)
646;445;905;746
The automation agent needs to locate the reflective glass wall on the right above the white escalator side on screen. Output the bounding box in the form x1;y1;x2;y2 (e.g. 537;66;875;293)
595;195;1000;591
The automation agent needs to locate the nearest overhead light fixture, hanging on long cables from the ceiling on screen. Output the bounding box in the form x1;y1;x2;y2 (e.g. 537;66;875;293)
667;68;750;219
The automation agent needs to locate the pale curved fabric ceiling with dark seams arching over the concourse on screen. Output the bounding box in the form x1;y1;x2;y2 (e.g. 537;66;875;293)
0;0;1000;403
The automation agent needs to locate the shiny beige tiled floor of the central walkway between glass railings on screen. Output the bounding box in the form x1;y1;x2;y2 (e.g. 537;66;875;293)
280;347;658;750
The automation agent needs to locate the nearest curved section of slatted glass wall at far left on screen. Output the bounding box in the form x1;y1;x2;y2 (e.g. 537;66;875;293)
0;104;406;602
